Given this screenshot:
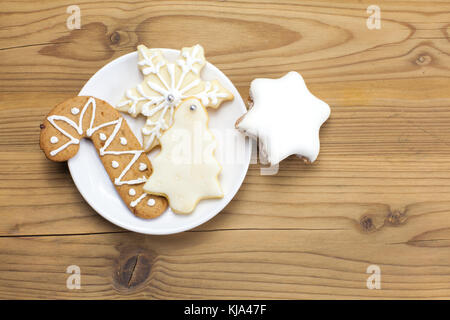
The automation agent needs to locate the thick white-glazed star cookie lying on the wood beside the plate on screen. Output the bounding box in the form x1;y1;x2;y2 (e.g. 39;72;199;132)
236;71;330;165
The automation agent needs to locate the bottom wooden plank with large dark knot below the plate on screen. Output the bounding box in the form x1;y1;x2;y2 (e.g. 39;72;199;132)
0;228;450;299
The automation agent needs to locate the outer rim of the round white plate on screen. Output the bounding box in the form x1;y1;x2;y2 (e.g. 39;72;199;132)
67;48;251;235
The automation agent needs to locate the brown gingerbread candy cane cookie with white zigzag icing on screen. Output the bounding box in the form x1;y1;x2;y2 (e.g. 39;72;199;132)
40;97;167;219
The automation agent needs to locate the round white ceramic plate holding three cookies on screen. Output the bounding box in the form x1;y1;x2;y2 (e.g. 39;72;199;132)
68;49;251;234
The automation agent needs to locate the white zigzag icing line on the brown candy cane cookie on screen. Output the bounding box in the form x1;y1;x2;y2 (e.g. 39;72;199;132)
47;97;147;205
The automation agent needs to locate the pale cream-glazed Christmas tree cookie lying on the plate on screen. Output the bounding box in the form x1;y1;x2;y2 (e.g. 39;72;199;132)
144;99;223;214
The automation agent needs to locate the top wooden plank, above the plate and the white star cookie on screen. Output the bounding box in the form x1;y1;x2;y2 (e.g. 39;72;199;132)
0;1;450;92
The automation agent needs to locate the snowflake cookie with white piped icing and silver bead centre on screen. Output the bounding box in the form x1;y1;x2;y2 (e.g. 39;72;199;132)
116;45;233;151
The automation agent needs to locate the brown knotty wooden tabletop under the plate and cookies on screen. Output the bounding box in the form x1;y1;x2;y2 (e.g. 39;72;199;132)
0;0;450;299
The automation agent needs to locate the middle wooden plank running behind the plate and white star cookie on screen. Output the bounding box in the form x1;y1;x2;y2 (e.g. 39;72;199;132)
0;87;450;235
